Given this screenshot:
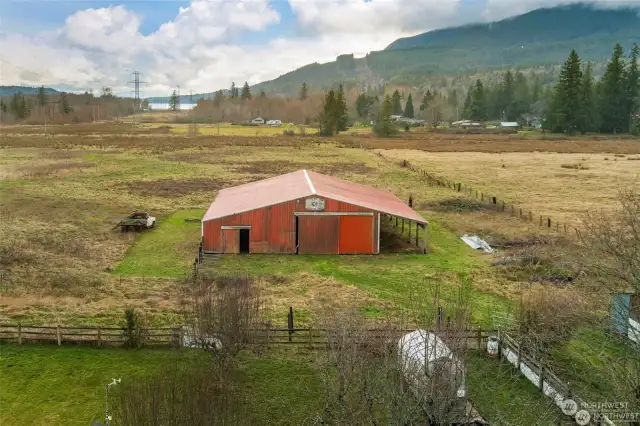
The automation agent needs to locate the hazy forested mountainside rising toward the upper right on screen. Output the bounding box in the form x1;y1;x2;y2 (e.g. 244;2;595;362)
253;5;640;95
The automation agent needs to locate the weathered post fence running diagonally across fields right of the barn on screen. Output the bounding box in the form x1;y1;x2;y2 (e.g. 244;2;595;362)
378;152;579;240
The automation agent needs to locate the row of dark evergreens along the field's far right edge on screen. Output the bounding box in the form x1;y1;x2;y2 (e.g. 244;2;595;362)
463;43;640;134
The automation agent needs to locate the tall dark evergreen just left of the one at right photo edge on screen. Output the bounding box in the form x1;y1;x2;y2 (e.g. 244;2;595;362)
600;43;629;133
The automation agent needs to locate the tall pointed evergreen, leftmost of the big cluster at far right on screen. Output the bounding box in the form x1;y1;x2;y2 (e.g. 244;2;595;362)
547;50;583;133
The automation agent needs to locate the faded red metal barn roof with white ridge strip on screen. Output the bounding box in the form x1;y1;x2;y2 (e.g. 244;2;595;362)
202;170;427;223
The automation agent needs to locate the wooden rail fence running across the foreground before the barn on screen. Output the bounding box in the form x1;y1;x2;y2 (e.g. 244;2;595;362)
0;324;496;349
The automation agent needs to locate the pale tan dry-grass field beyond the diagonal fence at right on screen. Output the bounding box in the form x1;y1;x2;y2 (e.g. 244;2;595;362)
383;150;640;225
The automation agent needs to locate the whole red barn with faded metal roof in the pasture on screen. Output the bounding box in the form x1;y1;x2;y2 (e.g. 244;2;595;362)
202;170;427;254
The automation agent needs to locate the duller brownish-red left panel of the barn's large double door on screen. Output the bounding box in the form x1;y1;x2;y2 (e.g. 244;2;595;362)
298;215;340;254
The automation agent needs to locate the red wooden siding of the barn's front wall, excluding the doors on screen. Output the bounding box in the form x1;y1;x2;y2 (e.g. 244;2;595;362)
203;197;377;253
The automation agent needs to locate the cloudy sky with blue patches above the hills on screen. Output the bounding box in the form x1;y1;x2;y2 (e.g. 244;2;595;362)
0;0;640;96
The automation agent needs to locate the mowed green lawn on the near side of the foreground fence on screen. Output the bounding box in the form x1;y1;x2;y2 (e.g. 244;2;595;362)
0;345;558;426
